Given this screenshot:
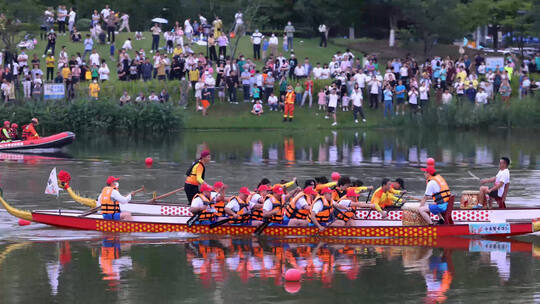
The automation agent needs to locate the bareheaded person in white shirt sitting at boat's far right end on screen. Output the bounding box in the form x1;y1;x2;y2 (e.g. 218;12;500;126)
478;157;510;209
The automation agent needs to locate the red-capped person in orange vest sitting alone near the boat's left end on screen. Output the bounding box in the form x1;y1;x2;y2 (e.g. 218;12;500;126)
97;176;134;221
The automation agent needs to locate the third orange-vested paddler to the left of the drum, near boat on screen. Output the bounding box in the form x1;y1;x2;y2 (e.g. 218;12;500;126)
283;186;318;227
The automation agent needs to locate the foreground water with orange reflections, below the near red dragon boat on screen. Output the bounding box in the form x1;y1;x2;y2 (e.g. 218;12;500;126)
0;235;540;303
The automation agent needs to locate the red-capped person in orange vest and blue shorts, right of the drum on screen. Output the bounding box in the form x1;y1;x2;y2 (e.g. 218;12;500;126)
418;166;452;225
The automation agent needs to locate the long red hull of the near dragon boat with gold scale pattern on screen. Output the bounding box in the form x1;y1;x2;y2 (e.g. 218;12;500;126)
0;190;540;238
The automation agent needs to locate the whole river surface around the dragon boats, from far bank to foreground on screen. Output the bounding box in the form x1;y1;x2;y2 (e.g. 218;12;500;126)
0;129;540;303
